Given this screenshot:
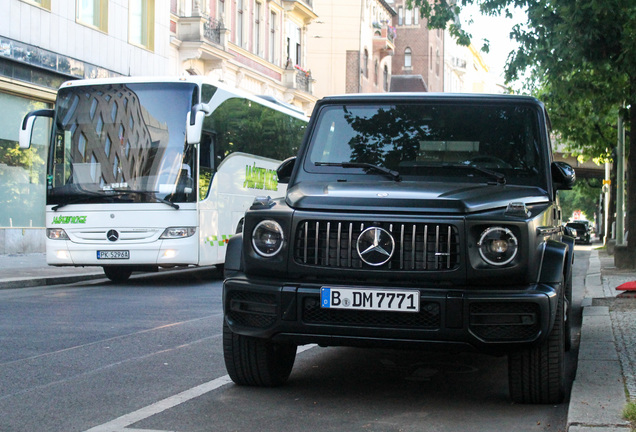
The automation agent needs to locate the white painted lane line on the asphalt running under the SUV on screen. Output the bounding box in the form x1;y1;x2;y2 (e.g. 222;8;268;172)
85;345;317;432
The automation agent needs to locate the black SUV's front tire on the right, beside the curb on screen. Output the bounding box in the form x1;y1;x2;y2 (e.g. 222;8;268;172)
508;282;565;404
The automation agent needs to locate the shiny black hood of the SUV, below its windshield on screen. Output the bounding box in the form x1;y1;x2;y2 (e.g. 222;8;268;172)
286;181;550;214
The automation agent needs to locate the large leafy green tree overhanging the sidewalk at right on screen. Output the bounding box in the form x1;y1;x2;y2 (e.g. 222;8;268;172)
410;0;636;264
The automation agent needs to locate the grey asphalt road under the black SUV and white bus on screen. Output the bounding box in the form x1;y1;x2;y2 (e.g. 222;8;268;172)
0;247;589;432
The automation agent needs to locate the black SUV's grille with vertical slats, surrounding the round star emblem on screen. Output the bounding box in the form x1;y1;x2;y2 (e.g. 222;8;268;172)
294;220;459;271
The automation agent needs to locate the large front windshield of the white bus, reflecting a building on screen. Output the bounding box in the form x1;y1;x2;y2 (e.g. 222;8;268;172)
47;83;198;208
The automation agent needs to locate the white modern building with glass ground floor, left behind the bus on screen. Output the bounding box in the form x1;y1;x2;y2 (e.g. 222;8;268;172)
0;0;170;253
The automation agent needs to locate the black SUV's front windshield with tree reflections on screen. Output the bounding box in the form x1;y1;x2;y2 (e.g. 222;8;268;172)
305;103;546;187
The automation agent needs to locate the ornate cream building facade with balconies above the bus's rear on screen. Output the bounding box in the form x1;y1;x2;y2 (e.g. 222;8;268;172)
170;0;317;113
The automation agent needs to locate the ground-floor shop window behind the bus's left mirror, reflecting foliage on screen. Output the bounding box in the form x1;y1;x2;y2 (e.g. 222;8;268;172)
0;93;51;228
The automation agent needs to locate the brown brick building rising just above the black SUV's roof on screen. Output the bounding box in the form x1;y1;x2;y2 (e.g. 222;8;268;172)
392;0;445;92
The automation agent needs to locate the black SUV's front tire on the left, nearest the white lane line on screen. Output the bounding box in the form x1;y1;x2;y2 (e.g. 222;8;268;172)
223;322;296;387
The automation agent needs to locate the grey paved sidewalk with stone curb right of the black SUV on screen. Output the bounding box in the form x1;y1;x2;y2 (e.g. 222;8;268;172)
567;250;636;432
